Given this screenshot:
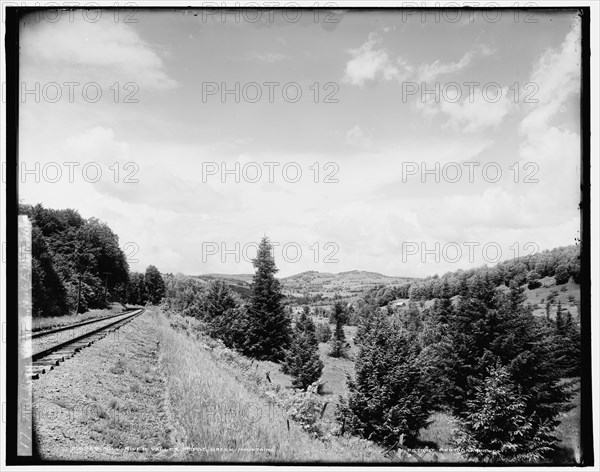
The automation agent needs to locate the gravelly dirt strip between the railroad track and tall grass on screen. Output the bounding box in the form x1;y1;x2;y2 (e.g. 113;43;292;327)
33;314;176;461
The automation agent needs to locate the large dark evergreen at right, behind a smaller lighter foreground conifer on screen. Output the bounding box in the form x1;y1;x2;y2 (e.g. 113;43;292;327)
449;282;571;456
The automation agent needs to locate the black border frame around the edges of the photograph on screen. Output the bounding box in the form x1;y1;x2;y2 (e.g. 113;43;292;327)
5;5;594;467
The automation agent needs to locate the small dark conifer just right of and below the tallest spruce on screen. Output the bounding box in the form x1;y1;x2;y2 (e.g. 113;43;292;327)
281;312;323;390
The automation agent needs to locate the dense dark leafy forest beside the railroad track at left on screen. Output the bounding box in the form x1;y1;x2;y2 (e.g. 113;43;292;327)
19;204;164;317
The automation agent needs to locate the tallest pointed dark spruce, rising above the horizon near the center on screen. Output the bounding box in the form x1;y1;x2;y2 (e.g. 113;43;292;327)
243;236;291;361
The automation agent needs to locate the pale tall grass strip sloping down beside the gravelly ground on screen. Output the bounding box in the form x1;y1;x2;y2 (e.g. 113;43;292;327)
151;309;389;462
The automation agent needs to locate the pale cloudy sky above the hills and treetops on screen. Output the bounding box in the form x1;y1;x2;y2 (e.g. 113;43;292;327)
19;10;580;276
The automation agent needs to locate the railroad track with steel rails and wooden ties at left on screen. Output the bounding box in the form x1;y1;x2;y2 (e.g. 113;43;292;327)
30;309;144;380
